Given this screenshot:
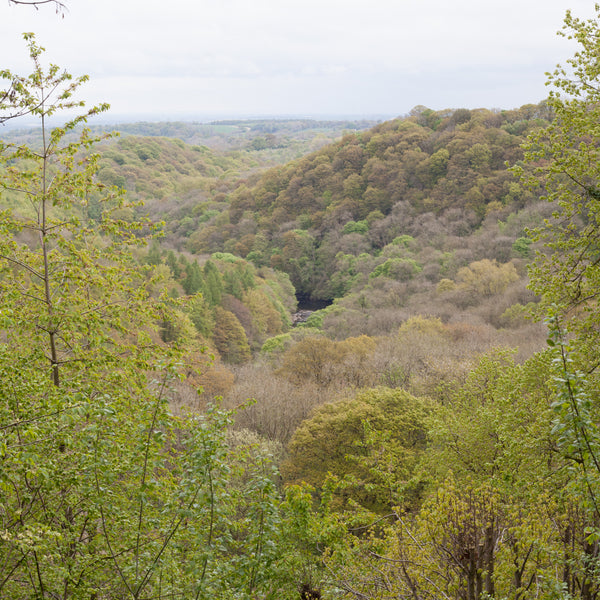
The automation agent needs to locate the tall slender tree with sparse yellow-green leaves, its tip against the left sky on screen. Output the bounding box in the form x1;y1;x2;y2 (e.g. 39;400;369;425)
0;34;136;386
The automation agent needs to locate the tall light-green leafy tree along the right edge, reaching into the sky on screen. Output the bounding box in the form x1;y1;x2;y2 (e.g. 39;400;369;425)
515;4;600;598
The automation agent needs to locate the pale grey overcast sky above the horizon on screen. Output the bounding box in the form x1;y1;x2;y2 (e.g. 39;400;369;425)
0;0;594;120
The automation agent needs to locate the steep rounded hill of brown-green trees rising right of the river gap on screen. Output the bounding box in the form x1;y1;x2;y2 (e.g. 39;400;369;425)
188;104;550;298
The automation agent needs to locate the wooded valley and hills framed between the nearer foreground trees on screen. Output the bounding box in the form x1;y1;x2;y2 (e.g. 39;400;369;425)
94;104;552;441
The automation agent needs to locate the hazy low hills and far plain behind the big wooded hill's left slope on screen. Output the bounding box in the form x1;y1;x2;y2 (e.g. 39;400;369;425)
88;119;374;248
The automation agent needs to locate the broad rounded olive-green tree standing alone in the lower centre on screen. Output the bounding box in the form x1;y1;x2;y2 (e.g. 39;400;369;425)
282;387;432;511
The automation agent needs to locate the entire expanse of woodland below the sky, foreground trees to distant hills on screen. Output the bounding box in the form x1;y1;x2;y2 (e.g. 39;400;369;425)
0;8;600;600
